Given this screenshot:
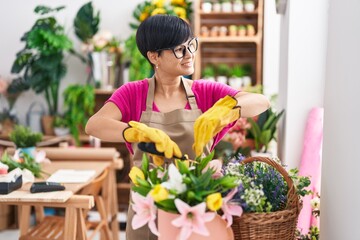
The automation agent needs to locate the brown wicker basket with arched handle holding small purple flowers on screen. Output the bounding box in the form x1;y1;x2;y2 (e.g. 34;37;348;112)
231;157;301;240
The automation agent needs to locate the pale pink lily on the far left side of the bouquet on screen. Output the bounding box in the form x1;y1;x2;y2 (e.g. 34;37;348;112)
131;192;159;236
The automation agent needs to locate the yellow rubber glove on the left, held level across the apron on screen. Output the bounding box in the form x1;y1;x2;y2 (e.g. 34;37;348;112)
123;121;182;158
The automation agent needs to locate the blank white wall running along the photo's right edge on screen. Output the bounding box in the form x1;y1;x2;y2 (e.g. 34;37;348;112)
321;0;360;240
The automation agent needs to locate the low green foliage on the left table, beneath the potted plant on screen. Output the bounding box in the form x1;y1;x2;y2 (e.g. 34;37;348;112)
1;152;41;178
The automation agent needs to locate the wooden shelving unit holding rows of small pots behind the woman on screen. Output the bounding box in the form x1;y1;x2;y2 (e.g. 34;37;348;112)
193;0;264;85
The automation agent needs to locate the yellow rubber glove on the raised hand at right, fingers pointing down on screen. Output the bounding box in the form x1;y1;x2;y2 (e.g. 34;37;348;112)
192;96;241;156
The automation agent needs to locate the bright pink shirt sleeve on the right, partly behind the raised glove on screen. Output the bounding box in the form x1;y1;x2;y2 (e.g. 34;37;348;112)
192;80;240;151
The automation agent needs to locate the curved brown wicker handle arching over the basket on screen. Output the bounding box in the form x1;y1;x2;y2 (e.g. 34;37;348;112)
241;157;300;211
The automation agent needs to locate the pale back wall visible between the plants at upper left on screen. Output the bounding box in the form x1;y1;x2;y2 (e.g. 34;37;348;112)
0;0;142;124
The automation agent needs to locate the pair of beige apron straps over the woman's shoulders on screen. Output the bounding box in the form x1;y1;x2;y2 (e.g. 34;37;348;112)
146;77;198;111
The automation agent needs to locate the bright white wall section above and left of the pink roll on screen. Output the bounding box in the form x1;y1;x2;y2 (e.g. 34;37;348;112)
278;0;328;167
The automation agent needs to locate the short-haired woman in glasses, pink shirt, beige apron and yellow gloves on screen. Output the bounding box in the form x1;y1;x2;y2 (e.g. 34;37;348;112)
86;15;269;240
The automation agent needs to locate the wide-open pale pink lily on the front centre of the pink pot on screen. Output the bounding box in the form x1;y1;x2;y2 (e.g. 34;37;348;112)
171;199;216;240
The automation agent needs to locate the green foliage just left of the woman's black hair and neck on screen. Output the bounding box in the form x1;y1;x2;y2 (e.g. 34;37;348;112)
124;34;153;81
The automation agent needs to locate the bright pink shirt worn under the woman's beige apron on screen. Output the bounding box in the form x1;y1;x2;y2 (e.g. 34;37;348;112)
106;79;238;153
